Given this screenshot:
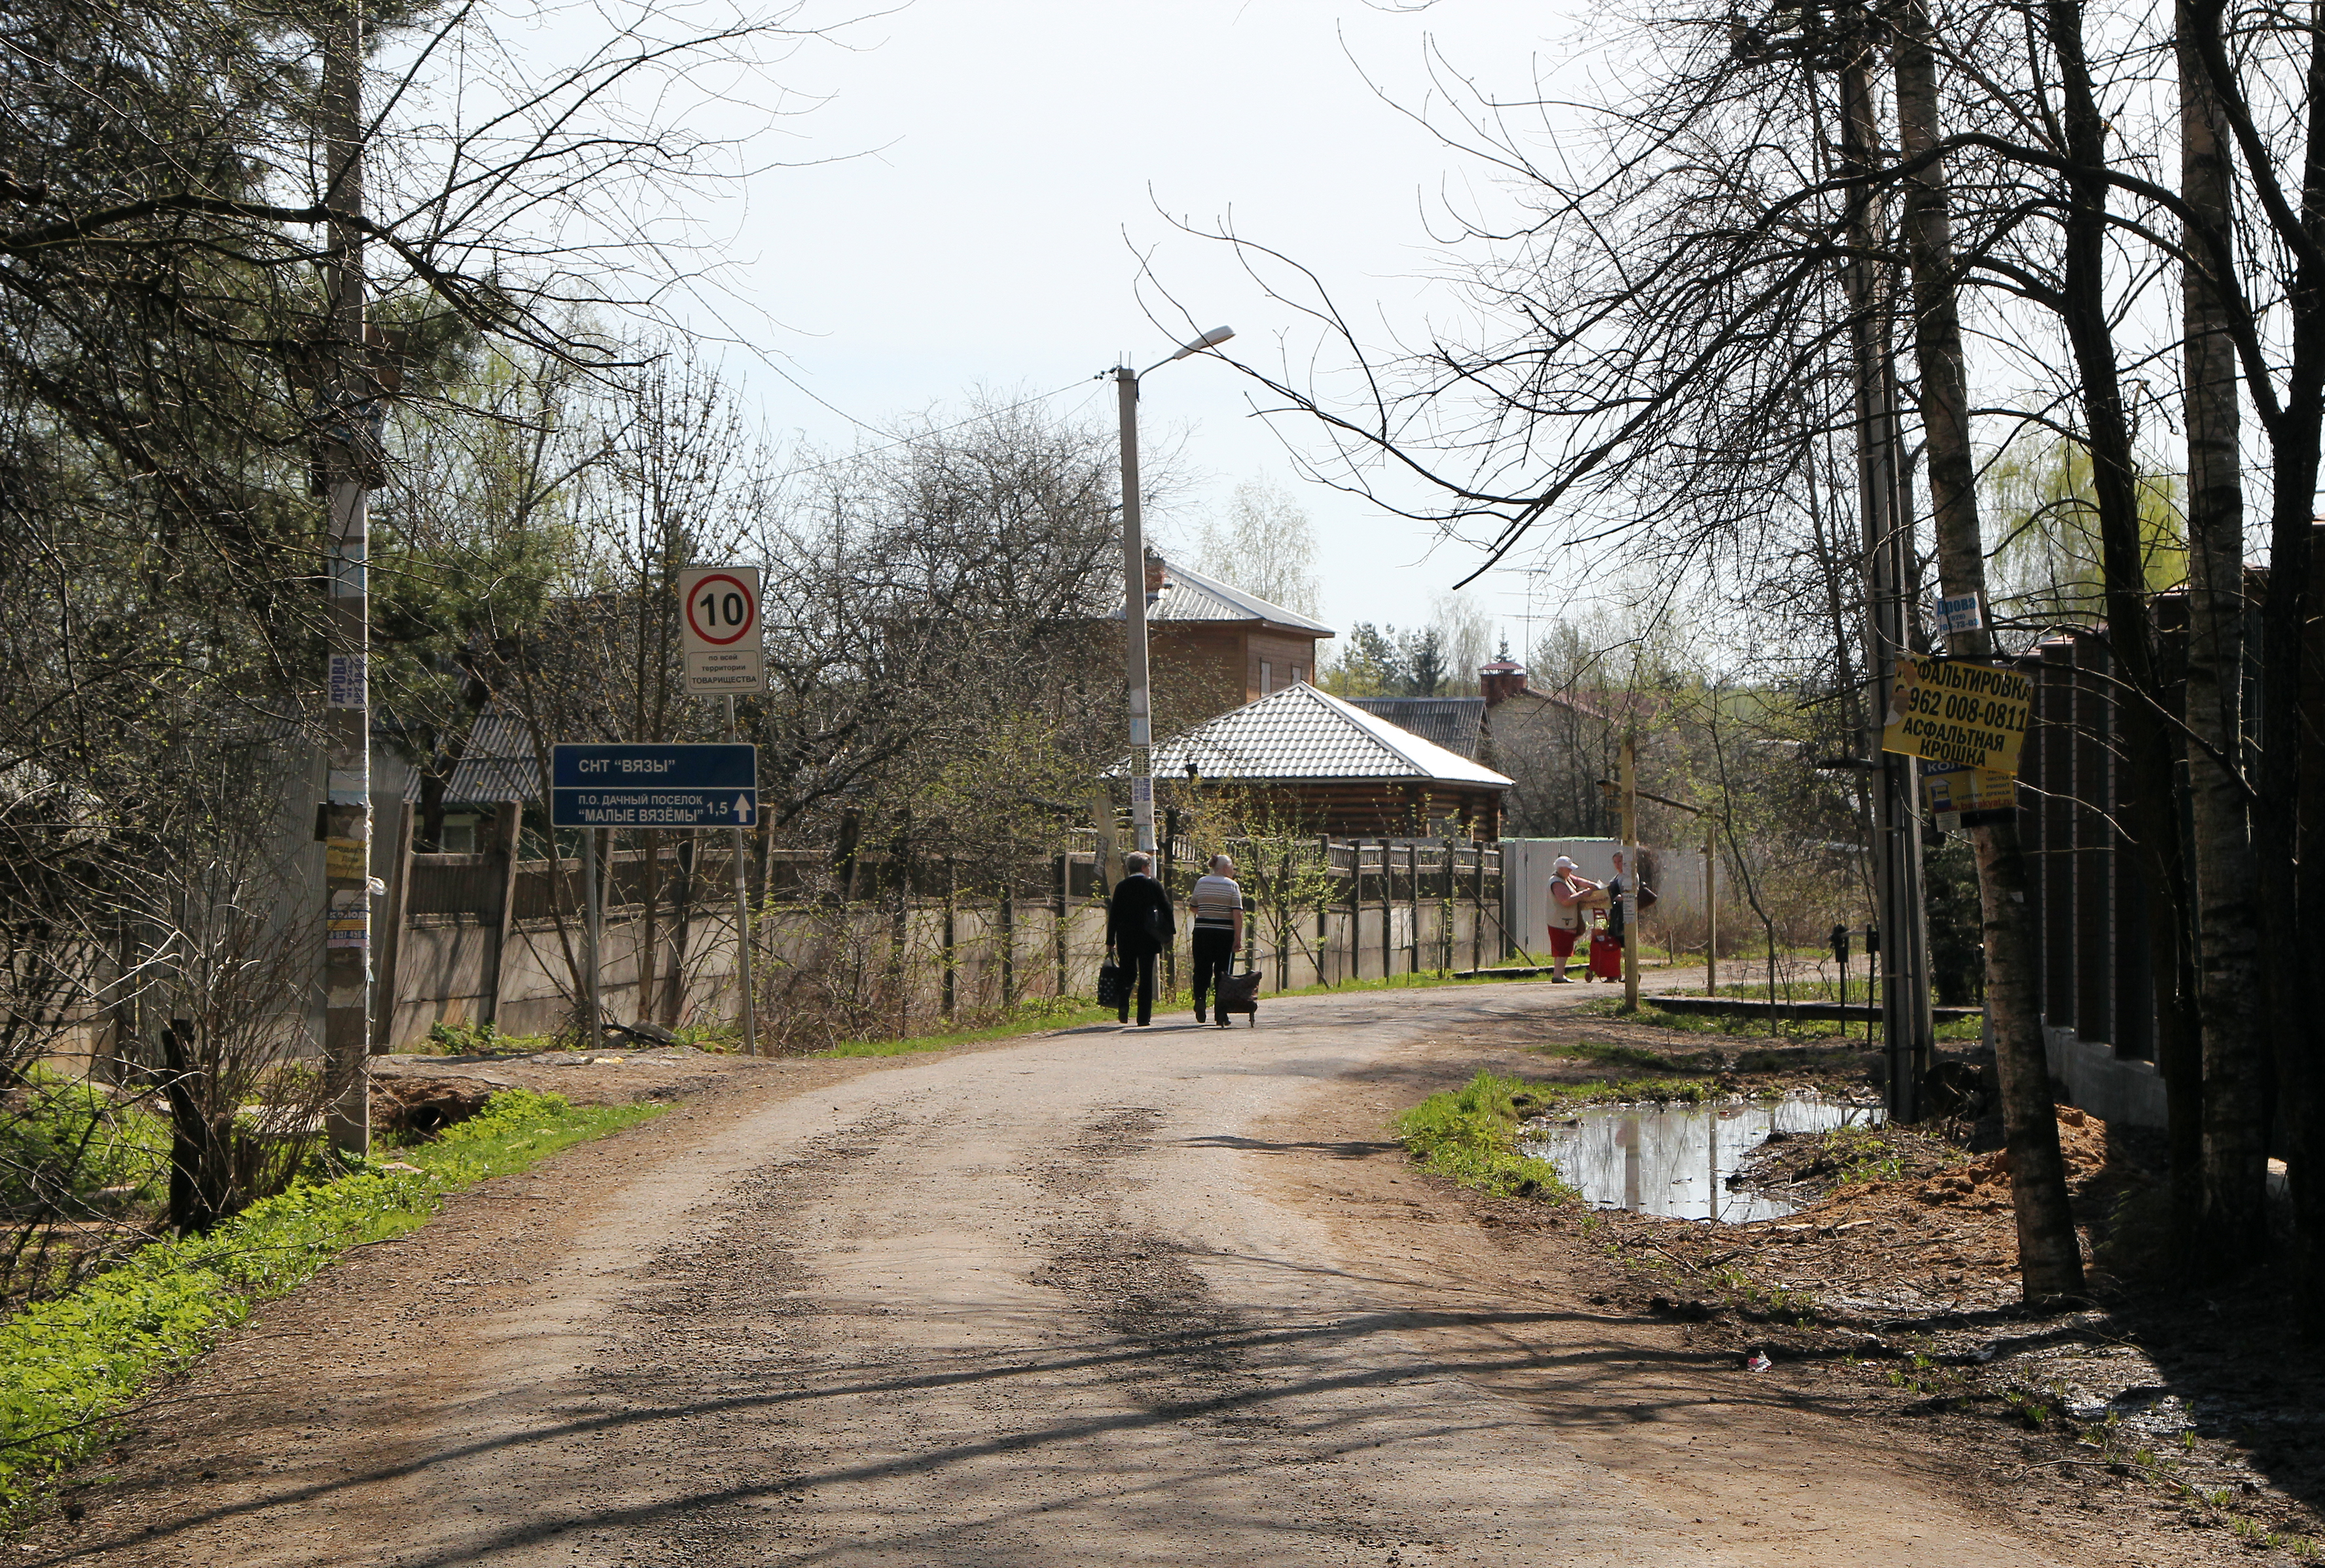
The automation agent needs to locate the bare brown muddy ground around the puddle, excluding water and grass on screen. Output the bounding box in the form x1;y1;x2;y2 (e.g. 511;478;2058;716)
1358;1013;2325;1561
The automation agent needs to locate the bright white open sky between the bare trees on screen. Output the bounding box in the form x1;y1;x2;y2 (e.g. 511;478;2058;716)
688;0;1574;664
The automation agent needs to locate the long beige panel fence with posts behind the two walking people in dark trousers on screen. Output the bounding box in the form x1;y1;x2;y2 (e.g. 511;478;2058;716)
374;829;1509;1050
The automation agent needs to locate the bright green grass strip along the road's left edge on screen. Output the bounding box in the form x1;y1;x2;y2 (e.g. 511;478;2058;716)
0;1090;660;1517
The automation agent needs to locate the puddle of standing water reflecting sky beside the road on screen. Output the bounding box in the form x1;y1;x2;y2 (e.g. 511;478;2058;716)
1521;1094;1883;1224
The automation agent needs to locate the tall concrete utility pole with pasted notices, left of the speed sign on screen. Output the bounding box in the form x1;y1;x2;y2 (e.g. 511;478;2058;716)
316;0;379;1154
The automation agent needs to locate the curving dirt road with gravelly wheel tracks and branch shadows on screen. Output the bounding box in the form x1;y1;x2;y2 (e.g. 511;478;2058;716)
36;985;2123;1568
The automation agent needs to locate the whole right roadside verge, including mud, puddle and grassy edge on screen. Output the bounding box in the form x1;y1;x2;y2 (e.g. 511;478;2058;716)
1397;1015;2325;1563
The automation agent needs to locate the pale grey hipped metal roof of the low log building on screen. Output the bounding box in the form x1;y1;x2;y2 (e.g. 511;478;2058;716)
1107;681;1509;790
